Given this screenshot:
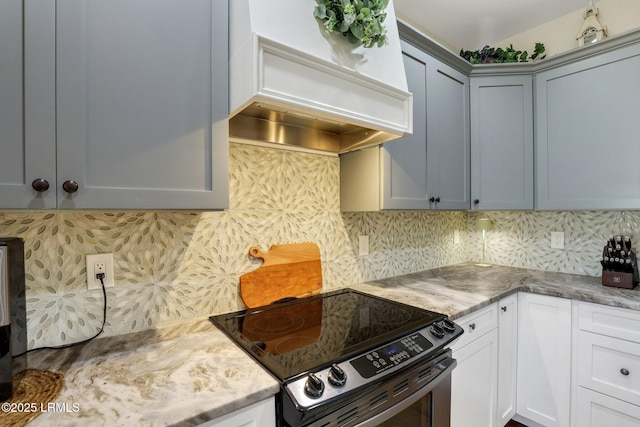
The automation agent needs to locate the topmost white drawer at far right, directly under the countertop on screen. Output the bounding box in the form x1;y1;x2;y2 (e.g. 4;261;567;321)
578;302;640;343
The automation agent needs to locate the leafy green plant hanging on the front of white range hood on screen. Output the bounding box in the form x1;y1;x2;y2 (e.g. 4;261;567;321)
313;0;389;47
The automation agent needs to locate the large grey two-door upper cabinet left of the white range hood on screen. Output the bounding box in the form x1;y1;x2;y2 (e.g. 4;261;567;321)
0;0;229;209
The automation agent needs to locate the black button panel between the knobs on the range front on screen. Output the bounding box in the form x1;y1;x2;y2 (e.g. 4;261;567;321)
350;333;433;378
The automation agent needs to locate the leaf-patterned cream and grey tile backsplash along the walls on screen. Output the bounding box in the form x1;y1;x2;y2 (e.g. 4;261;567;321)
0;143;637;348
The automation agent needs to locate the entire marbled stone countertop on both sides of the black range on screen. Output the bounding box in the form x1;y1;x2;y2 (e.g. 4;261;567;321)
22;263;640;427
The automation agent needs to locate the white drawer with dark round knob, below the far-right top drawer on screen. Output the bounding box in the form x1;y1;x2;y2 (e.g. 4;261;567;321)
578;331;640;403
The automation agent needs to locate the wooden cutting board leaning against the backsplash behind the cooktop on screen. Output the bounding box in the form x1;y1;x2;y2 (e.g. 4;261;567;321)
240;243;322;307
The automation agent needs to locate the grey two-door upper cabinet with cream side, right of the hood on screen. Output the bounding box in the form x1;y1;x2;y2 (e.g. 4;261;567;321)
340;41;470;211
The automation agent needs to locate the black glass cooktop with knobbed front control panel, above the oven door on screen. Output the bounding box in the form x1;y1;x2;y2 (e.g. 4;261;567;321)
210;289;462;425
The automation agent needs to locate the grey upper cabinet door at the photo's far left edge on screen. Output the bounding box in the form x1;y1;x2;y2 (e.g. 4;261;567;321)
0;0;56;209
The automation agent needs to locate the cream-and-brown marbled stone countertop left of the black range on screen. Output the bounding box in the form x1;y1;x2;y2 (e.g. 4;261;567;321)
27;319;280;427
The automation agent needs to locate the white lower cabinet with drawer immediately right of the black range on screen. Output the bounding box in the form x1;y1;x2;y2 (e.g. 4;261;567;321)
451;304;498;427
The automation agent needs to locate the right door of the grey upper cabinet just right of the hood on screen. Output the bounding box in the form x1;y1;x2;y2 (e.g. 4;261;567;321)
427;58;471;210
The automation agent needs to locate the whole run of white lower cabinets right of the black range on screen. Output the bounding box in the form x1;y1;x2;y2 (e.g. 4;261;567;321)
451;292;640;427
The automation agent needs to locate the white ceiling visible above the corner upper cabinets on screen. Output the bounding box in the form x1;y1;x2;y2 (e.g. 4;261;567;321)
393;0;588;50
